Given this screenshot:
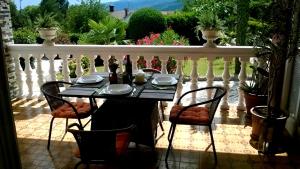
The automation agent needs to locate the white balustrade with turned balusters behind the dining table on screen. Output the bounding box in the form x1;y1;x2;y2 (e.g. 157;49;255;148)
8;44;254;109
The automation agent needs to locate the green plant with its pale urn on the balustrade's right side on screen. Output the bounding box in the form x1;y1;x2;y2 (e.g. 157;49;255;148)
196;10;222;47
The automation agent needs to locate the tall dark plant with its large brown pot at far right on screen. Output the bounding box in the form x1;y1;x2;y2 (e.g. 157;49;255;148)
250;0;300;154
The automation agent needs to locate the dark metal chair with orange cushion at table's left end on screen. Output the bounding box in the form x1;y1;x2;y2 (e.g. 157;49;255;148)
41;81;97;150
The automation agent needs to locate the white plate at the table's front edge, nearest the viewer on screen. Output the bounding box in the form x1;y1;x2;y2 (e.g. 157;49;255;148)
104;84;132;95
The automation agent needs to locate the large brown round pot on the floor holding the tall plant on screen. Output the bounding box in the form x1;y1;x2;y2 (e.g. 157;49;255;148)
250;106;287;152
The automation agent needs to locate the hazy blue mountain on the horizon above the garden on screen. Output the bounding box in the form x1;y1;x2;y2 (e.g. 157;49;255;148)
105;0;182;11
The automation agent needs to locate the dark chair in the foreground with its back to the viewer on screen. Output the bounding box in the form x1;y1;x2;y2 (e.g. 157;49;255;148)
68;123;135;168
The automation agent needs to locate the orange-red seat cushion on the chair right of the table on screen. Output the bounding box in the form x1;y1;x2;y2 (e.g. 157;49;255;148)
169;105;209;124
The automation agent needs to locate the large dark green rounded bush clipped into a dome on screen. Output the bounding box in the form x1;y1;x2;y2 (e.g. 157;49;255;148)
127;8;166;41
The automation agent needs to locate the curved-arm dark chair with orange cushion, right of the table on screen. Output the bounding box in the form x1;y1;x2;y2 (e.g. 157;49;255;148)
165;87;226;164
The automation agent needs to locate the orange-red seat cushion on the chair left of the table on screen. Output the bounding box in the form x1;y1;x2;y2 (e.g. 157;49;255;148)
51;102;91;118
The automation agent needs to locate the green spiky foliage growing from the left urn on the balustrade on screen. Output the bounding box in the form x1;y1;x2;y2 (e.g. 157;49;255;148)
34;13;59;28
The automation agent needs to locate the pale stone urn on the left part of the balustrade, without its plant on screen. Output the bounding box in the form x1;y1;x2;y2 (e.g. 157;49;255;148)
38;27;57;46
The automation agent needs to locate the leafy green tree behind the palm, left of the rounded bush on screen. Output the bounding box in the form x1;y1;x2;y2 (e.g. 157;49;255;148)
66;0;108;33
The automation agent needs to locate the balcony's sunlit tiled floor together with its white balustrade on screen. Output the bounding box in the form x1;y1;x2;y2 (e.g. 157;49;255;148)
8;44;300;169
